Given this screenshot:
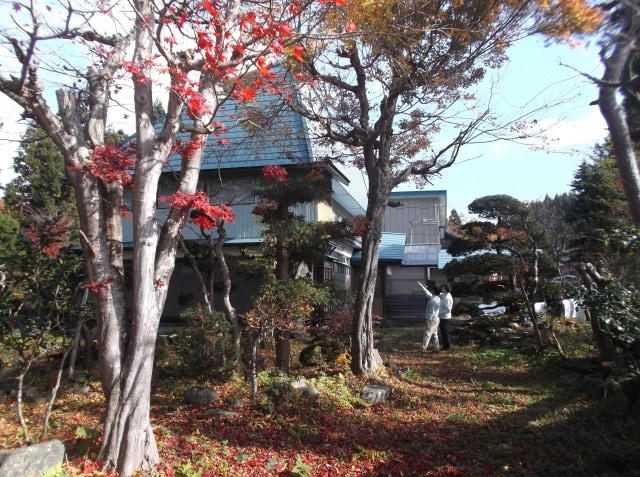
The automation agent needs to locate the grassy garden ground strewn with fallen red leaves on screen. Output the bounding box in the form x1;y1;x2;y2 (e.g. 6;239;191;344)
0;318;640;477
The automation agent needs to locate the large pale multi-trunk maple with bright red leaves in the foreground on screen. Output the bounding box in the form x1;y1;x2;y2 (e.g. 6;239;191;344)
0;0;333;476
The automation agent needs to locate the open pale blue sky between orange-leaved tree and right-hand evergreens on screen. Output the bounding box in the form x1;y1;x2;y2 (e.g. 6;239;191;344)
399;36;607;215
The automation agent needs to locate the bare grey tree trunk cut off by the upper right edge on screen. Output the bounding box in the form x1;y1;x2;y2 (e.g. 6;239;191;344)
598;6;640;225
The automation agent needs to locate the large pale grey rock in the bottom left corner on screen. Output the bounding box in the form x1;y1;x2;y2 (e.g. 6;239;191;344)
0;439;64;477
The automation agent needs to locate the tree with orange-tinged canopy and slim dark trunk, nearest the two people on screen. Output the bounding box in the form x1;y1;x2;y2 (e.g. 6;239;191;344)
288;0;600;374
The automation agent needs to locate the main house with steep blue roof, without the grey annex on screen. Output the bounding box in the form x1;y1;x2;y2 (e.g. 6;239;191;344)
123;89;365;321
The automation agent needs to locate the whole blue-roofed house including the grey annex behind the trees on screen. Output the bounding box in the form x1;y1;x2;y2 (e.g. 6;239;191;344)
123;89;446;320
